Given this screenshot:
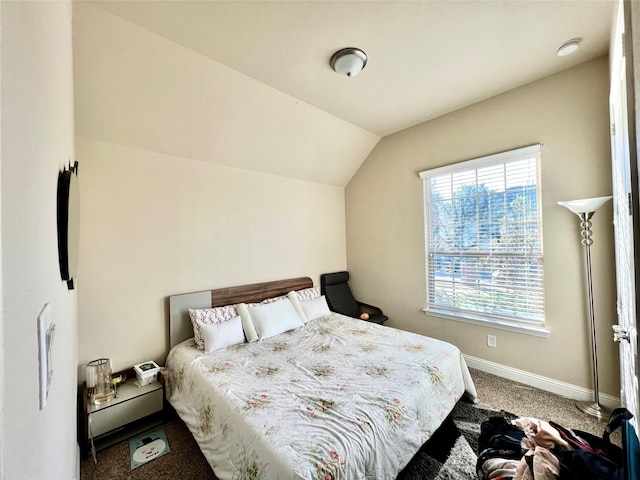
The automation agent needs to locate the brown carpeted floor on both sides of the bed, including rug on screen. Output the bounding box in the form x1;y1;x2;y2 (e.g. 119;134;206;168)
81;370;604;480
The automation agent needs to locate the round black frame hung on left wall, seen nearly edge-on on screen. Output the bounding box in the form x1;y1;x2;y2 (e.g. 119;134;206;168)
57;162;80;290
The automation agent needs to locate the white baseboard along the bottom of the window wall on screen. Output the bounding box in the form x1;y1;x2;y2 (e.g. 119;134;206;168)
463;354;620;409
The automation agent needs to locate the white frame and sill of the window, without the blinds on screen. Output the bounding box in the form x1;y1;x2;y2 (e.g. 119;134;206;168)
419;144;550;337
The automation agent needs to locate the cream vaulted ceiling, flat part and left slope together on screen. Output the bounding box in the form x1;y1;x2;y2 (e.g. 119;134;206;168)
74;0;615;185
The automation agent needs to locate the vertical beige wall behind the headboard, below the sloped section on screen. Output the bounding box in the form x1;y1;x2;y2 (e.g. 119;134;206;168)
76;137;346;374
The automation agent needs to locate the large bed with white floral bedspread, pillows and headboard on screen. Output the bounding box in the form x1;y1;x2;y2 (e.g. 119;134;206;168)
166;277;476;480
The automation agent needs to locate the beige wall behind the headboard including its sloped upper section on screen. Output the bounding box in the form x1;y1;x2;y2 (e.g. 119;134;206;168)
73;2;358;378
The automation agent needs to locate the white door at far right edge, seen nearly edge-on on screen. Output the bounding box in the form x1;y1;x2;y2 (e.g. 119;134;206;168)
609;2;640;429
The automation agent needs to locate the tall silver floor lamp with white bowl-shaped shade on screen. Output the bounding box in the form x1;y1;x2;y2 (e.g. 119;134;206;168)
558;197;612;420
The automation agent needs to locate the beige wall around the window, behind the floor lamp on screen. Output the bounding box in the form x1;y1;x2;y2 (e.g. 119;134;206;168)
345;59;619;397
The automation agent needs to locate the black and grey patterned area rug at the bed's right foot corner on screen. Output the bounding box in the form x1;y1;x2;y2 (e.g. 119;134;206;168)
397;401;516;480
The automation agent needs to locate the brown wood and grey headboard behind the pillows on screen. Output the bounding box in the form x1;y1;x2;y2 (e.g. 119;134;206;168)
169;277;313;348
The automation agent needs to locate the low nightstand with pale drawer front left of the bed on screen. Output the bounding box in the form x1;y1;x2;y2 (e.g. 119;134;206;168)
78;369;164;458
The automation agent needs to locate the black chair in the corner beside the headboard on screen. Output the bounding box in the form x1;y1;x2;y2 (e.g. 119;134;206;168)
320;272;388;325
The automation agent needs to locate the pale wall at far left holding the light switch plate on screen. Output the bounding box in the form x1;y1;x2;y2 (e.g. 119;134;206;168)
0;1;77;480
